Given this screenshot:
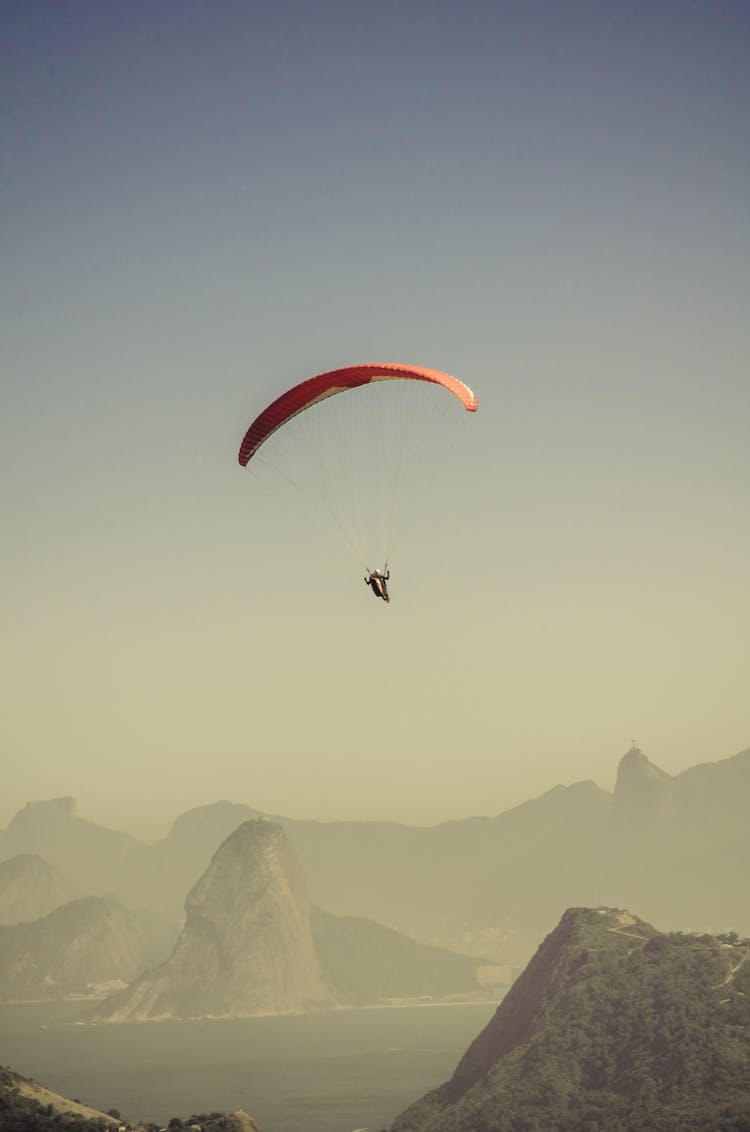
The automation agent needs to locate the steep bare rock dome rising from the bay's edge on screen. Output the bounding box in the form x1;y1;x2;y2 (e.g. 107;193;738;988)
97;821;334;1022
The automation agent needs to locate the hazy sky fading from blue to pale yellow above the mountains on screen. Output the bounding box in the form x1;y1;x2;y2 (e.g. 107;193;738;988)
0;0;750;837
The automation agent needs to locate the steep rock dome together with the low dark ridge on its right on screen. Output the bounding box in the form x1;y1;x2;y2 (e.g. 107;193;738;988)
93;818;479;1022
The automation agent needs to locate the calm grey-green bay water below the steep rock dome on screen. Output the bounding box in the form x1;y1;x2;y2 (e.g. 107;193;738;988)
0;1003;504;1132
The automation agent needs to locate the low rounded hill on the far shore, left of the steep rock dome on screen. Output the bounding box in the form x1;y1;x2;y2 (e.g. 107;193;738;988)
0;897;146;1001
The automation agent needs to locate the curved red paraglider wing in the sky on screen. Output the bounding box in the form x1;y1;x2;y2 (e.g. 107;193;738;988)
239;363;477;466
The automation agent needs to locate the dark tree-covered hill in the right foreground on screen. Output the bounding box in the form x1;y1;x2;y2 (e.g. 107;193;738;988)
391;909;750;1132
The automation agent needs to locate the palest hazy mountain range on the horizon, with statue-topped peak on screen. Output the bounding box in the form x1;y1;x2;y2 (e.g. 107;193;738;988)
0;747;750;966
